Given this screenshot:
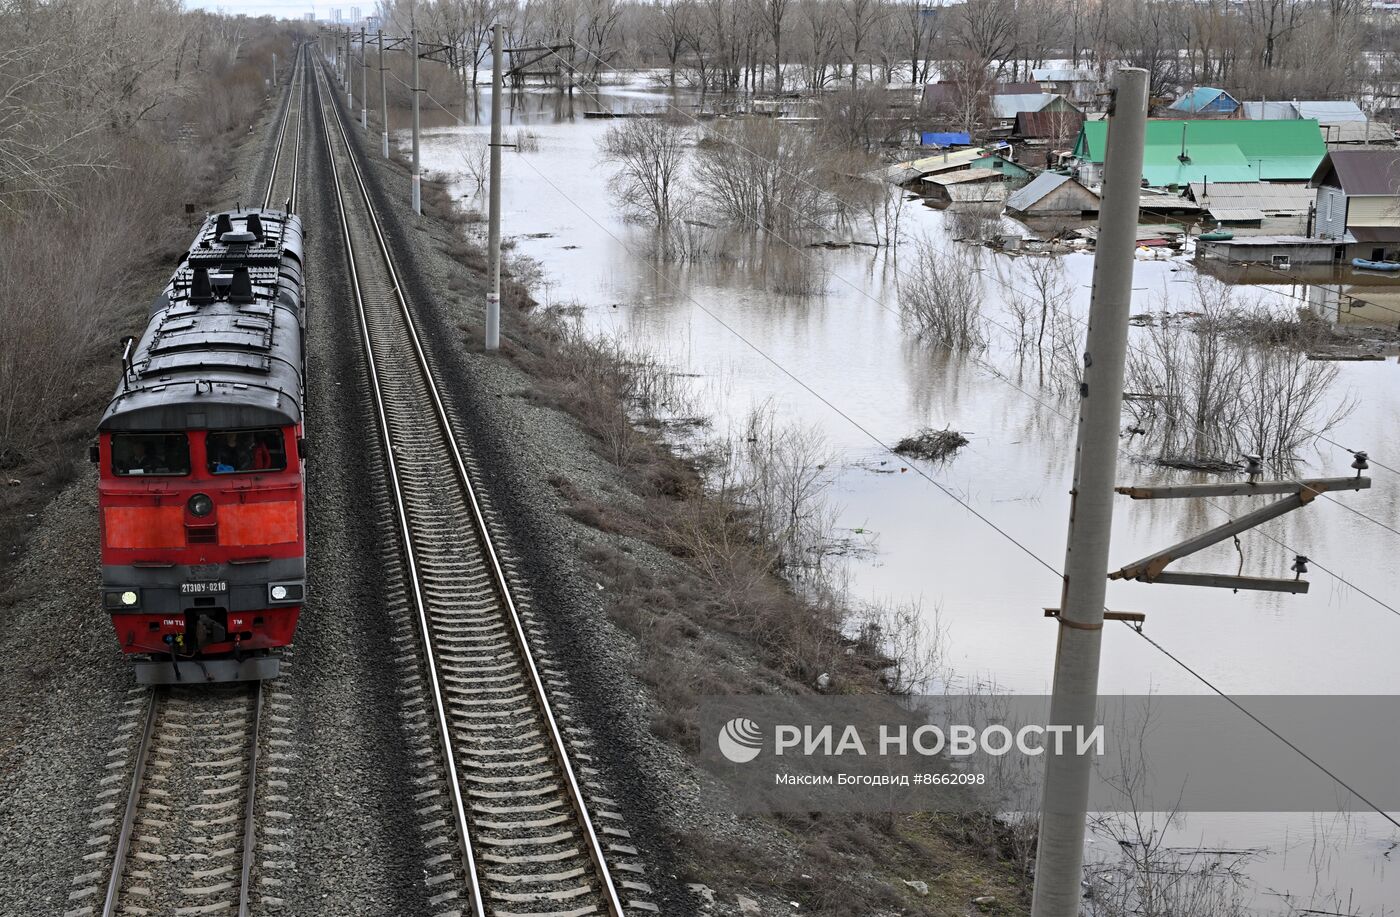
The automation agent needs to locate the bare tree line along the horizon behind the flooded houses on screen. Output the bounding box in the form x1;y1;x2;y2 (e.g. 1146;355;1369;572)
381;0;1394;98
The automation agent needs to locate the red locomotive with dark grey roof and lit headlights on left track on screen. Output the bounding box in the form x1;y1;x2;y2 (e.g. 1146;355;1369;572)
92;210;307;685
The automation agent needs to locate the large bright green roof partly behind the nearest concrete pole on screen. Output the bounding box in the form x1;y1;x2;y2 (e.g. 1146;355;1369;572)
1074;118;1327;188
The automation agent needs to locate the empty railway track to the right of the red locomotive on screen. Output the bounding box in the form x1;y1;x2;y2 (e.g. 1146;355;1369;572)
315;52;641;917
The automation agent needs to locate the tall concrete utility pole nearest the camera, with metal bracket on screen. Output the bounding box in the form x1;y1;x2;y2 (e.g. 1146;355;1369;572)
1030;67;1147;917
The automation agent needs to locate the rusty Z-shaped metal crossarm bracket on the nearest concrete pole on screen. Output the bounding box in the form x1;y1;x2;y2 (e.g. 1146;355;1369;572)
1109;475;1371;592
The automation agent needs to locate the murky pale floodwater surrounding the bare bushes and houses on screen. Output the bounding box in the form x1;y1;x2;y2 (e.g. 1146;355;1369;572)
403;85;1400;914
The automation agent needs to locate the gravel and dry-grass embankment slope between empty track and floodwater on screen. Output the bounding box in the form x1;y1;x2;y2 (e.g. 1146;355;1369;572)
367;121;1029;916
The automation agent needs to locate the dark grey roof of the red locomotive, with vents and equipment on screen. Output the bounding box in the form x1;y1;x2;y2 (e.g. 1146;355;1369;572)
98;210;302;431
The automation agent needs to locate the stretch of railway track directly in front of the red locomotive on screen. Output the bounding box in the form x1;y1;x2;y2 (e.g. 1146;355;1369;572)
102;682;262;917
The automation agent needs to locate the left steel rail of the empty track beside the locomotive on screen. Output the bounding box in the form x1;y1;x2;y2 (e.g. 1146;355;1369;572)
306;55;486;917
